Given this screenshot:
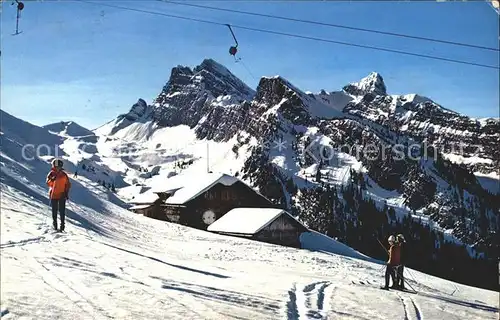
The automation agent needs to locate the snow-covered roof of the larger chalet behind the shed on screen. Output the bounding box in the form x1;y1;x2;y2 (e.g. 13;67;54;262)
153;173;264;204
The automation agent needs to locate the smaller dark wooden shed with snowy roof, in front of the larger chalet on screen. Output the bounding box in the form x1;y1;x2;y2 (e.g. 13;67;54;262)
207;208;309;248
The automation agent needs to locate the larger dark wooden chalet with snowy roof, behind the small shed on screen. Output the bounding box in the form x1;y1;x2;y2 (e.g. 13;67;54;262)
148;173;276;230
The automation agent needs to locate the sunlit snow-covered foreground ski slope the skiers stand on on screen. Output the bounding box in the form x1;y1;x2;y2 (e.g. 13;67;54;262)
0;114;499;320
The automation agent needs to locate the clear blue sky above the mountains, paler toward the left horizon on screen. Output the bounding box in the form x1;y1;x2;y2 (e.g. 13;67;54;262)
1;0;499;129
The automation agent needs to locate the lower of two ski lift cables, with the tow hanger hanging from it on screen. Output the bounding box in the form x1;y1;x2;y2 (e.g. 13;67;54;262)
75;0;500;70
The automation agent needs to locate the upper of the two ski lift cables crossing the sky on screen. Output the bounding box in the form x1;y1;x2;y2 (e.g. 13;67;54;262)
156;0;500;52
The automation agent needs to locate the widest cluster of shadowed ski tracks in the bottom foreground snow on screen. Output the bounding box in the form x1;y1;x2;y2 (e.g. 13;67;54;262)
286;281;335;320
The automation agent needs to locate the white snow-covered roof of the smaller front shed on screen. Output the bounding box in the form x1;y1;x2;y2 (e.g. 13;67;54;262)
207;208;300;235
